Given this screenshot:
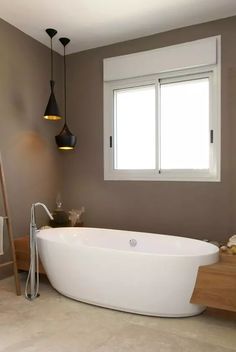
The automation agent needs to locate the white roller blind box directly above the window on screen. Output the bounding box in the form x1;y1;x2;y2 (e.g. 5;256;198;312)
103;36;220;81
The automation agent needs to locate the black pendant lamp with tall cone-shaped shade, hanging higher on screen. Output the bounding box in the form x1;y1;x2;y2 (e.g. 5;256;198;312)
43;28;62;121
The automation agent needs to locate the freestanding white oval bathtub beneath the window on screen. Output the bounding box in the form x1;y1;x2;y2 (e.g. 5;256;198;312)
37;228;219;317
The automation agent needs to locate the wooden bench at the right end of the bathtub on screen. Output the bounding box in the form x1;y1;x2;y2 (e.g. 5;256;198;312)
190;253;236;312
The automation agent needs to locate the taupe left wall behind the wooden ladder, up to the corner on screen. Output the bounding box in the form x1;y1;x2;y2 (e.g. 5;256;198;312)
0;20;62;275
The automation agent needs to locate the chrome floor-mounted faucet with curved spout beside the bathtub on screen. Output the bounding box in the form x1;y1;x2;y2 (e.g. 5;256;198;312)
25;203;53;301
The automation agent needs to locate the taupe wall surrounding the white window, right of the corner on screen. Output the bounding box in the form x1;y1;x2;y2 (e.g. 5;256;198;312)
61;17;236;239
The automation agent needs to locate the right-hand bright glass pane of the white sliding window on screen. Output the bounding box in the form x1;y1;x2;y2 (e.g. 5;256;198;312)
161;78;209;169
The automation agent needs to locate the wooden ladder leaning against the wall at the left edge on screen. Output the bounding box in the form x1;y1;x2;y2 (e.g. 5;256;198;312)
0;156;21;296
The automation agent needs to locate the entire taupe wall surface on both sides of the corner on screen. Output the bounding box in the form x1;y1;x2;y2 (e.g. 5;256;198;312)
0;17;236;275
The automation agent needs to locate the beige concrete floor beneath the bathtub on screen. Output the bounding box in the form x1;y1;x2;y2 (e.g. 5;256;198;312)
0;277;236;352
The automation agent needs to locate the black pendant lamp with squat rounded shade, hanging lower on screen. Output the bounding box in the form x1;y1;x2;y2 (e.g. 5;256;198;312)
55;38;76;150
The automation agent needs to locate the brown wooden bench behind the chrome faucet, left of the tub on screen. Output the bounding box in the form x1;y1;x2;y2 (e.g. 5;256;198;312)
14;236;46;274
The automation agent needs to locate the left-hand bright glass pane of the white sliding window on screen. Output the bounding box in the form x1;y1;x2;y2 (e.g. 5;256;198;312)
114;85;156;170
